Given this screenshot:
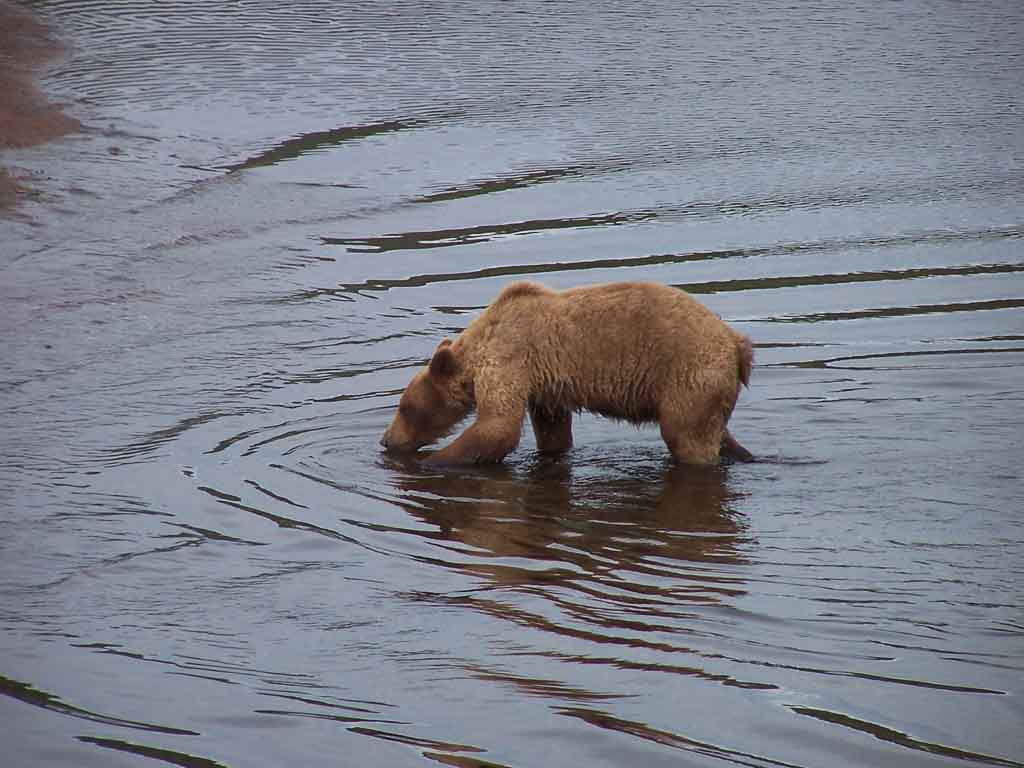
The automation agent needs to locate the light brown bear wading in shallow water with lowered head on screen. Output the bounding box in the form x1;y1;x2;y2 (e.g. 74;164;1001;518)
381;282;754;464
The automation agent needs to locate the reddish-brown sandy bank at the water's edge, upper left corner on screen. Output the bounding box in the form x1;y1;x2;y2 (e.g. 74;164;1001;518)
0;0;81;212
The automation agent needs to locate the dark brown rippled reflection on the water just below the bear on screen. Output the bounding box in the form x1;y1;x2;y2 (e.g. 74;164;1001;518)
392;460;749;603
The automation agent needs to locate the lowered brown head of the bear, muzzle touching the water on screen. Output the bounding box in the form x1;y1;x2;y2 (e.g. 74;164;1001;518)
381;339;473;451
